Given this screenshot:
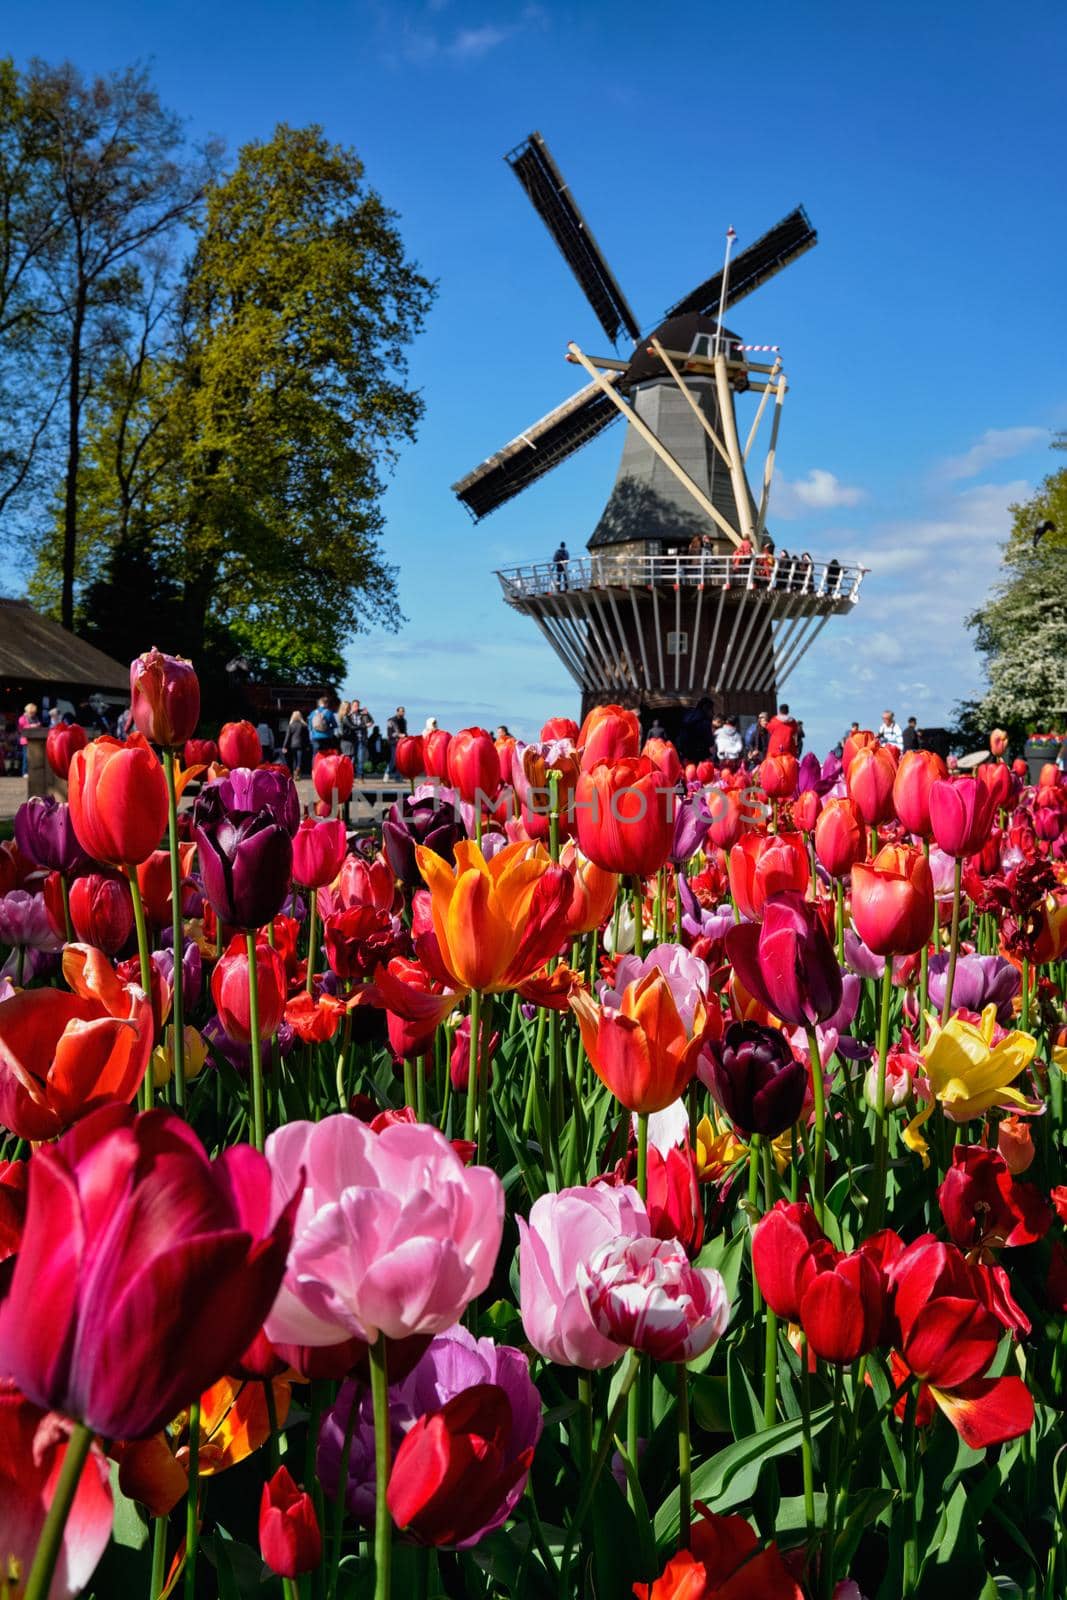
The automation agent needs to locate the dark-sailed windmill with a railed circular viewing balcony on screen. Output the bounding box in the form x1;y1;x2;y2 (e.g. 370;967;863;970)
453;133;864;723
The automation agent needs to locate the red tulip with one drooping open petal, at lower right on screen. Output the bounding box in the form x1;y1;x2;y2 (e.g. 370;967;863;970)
888;1234;1033;1450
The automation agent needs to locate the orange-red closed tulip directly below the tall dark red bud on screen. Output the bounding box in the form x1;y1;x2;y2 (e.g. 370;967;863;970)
67;734;166;867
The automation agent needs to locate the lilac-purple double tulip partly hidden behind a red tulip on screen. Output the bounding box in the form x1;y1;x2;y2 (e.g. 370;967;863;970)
317;1323;541;1546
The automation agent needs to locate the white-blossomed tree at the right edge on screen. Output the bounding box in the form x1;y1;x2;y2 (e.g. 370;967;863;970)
961;469;1067;742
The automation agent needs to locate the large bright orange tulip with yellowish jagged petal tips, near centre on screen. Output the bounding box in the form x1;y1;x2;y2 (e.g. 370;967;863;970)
414;838;573;994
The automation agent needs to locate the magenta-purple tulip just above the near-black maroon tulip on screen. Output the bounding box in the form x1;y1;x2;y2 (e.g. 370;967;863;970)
726;893;841;1027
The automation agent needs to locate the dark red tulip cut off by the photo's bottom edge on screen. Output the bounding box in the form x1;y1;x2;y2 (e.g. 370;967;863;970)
633;1502;799;1600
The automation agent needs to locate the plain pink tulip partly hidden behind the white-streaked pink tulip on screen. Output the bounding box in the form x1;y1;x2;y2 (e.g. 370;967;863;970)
517;1187;649;1371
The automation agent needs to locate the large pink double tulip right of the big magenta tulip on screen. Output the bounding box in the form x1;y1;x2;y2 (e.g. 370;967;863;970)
266;1114;504;1346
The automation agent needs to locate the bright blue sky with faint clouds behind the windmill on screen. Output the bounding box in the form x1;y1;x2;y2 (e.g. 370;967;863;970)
3;0;1067;747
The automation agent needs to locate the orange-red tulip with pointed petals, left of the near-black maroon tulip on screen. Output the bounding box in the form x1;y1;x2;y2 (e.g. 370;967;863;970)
571;966;712;1112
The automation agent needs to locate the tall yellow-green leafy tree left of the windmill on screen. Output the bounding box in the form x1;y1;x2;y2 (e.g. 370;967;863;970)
38;116;434;682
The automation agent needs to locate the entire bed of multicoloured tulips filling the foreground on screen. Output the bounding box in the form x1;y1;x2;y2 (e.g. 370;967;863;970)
0;665;1067;1600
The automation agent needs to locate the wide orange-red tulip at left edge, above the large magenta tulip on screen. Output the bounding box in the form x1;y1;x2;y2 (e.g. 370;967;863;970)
0;944;152;1141
